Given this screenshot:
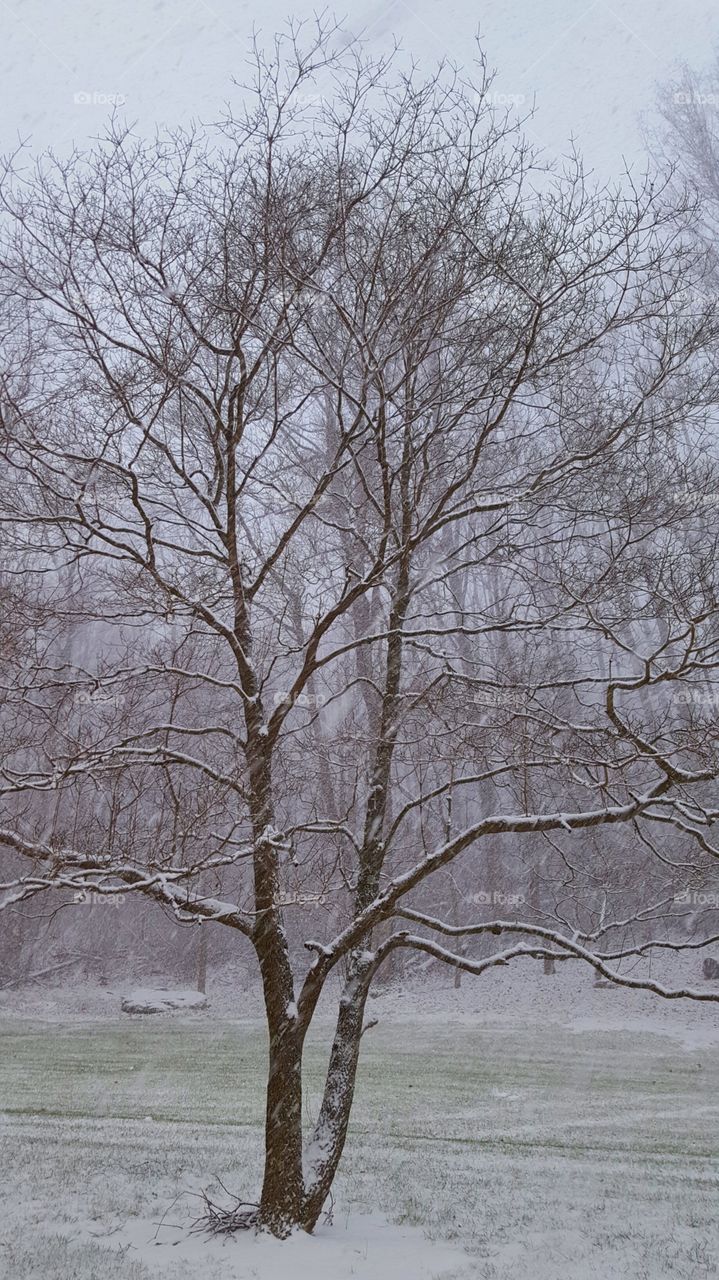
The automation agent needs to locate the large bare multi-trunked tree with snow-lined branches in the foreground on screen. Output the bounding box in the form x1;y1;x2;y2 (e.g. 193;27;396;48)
0;27;719;1235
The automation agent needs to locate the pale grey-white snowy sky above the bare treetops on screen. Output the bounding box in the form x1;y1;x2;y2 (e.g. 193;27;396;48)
0;0;719;178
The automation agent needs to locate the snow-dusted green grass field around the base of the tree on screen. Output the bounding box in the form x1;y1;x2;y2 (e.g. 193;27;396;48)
0;1015;719;1280
